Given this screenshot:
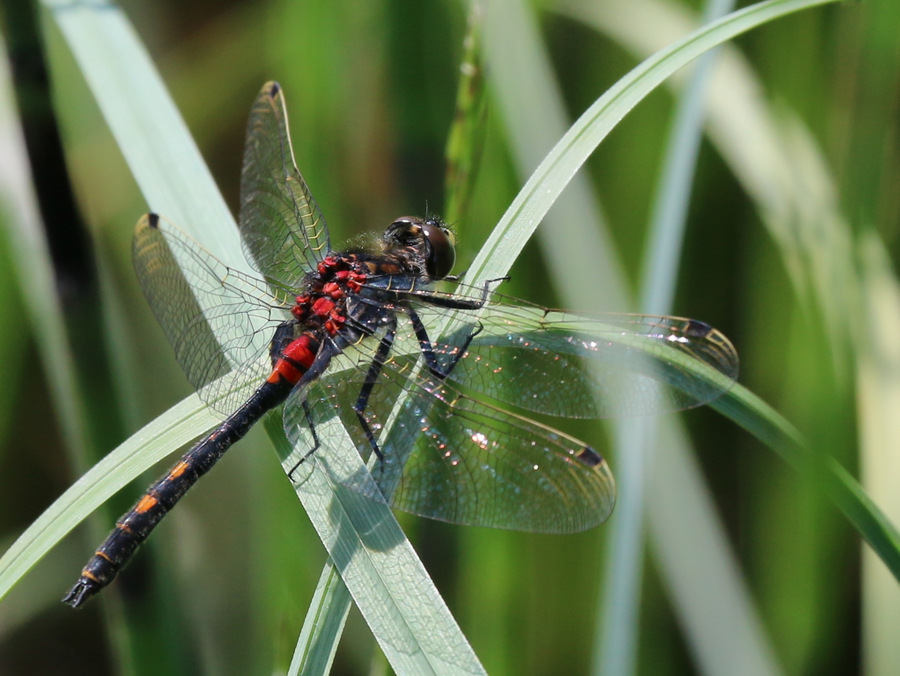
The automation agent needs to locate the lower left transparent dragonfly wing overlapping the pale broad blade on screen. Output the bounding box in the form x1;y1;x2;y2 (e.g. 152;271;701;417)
132;214;290;414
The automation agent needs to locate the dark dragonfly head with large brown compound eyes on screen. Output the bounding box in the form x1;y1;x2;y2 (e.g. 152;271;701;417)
384;216;456;279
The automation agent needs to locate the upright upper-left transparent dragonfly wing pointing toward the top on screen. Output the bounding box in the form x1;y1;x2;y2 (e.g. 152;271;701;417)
239;82;330;288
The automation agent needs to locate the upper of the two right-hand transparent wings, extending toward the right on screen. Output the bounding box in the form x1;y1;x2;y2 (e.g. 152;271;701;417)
372;287;738;418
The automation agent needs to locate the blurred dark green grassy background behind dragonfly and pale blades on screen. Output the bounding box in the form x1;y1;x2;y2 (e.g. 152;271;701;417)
0;0;900;674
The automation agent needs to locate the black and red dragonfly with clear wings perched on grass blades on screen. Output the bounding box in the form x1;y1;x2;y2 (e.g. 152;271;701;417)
63;82;738;608
